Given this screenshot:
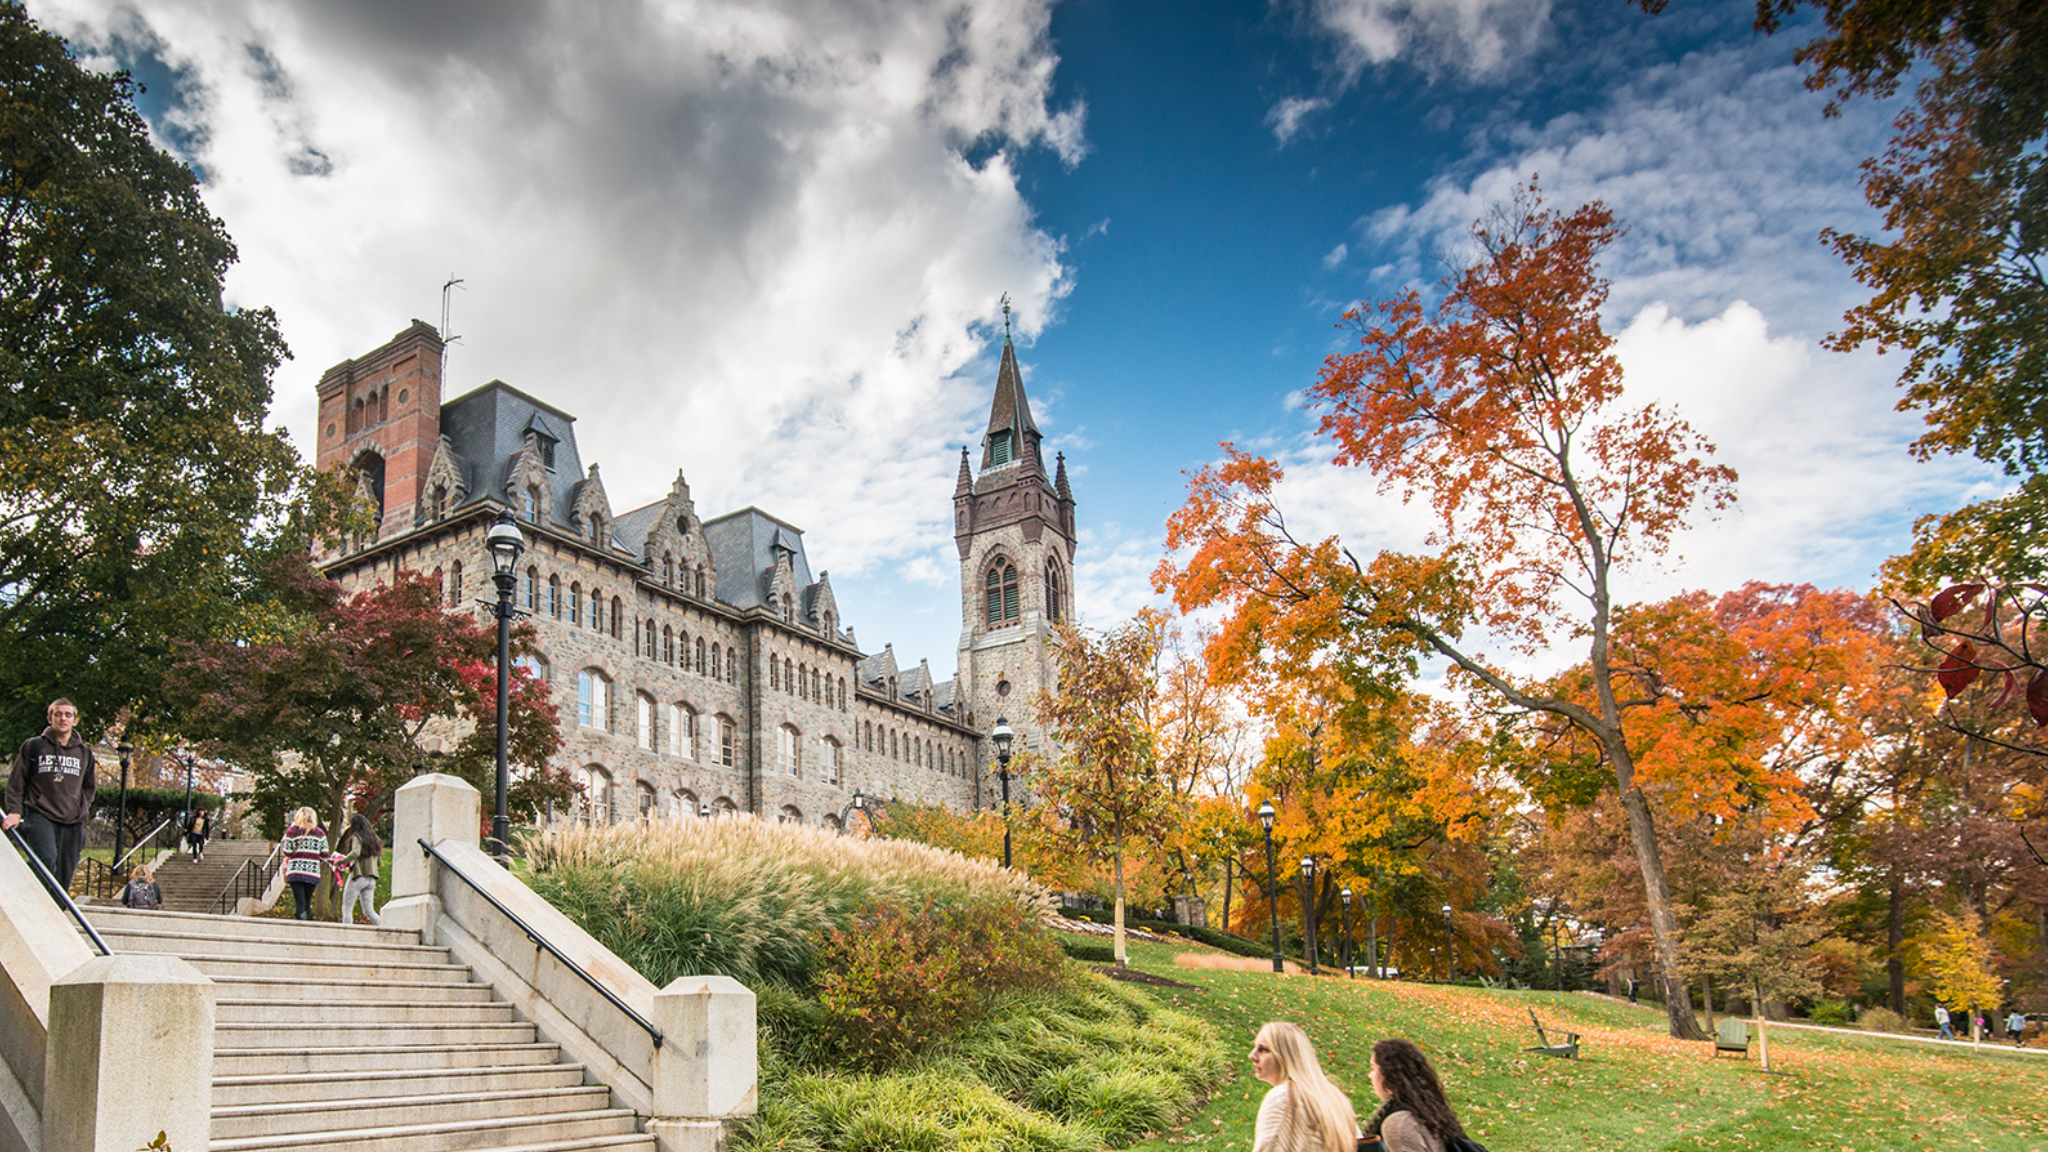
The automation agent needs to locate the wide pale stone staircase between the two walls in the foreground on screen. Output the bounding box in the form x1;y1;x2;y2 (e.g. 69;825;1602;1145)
86;901;655;1152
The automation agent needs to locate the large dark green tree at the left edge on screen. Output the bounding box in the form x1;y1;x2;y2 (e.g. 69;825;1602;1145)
0;2;303;730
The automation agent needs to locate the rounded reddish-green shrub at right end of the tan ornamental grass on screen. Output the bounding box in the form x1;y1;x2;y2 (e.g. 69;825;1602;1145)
817;902;1061;1068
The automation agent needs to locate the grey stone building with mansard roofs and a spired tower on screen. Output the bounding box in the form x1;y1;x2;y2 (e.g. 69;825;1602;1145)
315;320;1073;824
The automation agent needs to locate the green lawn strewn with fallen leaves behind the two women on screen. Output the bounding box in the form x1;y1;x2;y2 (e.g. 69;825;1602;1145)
1097;945;2048;1152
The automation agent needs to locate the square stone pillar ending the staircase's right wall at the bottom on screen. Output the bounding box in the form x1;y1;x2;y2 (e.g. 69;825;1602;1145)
647;976;758;1152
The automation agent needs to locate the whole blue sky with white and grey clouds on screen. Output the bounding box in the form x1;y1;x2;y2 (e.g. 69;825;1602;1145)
31;0;1993;674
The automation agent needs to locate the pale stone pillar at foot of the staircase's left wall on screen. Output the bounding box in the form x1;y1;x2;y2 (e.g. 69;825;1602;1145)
43;955;215;1152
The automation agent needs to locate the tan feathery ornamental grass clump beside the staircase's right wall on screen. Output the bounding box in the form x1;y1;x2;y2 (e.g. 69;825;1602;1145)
520;816;1053;988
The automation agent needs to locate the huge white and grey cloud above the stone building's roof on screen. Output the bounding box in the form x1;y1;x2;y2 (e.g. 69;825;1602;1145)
31;0;1087;619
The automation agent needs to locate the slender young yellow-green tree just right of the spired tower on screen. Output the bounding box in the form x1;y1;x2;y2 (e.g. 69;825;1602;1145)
1026;613;1176;965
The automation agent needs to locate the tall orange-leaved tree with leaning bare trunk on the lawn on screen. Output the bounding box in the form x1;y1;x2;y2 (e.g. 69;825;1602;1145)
1157;182;1735;1037
